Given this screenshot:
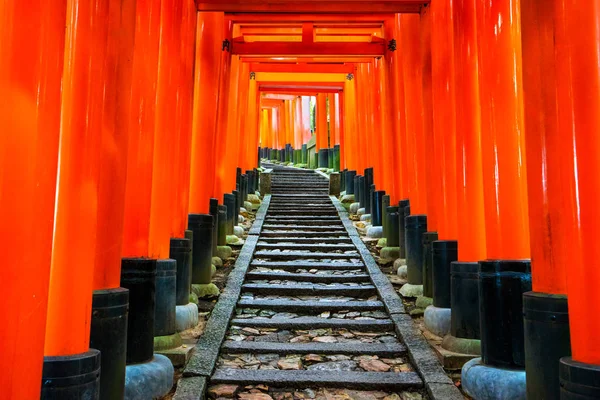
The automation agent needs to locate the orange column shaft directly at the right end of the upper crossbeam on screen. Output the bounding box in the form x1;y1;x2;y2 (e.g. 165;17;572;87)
386;14;408;200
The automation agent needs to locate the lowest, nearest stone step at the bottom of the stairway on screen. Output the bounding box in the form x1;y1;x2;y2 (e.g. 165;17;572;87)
211;369;423;392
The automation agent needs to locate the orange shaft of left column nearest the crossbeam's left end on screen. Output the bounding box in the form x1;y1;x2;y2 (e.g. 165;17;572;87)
189;12;224;214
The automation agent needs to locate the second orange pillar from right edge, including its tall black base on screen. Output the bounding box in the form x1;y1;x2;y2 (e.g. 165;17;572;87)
521;0;575;399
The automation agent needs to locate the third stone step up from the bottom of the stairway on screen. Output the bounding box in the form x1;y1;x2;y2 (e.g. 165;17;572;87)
231;317;394;332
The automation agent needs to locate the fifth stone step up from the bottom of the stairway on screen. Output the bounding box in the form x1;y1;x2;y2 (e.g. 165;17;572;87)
242;283;375;297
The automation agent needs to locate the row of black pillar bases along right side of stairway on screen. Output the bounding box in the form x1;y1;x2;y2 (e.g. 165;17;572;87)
341;168;572;399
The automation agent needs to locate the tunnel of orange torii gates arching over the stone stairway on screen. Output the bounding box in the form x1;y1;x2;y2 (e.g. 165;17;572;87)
0;0;600;399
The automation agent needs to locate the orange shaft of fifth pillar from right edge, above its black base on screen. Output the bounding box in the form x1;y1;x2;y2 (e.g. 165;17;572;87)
428;0;458;240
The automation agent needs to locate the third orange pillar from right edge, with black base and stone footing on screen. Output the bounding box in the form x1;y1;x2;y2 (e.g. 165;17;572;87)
462;0;531;398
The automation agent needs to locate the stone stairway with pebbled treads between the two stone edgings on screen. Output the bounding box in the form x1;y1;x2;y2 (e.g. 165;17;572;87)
209;168;427;400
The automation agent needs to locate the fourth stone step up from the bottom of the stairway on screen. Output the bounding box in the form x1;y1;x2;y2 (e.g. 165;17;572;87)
238;299;383;313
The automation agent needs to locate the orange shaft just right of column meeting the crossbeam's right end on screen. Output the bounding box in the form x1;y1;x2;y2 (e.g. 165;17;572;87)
400;14;427;214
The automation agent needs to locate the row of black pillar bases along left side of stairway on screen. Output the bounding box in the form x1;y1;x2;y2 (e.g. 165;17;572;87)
44;168;259;400
